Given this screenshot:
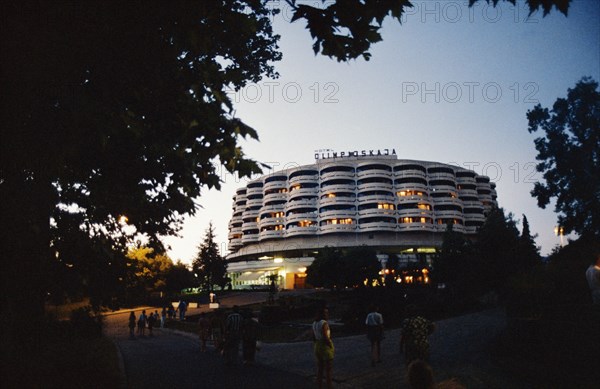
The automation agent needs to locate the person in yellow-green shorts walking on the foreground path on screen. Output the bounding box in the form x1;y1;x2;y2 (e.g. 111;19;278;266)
312;307;335;389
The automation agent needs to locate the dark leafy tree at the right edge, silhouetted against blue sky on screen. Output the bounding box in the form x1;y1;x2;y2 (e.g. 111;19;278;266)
527;77;600;239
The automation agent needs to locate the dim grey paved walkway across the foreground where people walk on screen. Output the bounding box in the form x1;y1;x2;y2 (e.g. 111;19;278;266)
107;294;523;389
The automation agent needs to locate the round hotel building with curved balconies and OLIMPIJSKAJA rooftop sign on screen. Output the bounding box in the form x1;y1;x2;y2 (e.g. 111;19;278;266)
227;149;497;289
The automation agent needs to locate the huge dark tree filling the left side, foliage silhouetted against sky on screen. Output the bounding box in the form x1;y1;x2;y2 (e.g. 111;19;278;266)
0;0;281;344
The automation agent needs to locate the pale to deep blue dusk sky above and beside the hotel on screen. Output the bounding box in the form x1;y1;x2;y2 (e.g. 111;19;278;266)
165;0;600;263
